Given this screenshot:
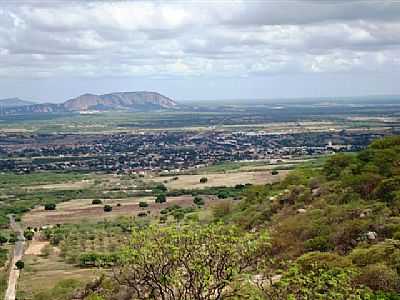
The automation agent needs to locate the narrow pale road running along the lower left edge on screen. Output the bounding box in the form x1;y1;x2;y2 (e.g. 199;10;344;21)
4;216;25;300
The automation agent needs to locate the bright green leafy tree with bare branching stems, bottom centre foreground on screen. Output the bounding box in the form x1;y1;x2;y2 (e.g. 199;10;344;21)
104;224;269;300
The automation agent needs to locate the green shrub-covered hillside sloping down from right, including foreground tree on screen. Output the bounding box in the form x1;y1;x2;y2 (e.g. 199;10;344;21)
66;137;400;300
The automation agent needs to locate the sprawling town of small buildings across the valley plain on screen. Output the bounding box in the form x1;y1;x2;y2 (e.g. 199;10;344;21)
0;130;384;174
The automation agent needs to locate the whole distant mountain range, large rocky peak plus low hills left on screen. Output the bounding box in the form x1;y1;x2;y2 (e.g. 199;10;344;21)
0;91;177;114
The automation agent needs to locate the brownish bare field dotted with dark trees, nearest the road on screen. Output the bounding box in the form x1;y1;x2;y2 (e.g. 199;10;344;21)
22;196;207;227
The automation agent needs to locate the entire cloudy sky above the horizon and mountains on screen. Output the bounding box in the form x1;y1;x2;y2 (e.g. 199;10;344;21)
0;0;400;102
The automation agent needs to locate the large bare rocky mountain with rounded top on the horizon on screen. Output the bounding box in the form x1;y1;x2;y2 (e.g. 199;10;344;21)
63;92;176;111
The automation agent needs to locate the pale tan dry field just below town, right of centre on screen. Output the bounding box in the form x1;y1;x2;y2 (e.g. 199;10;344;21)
152;170;289;189
